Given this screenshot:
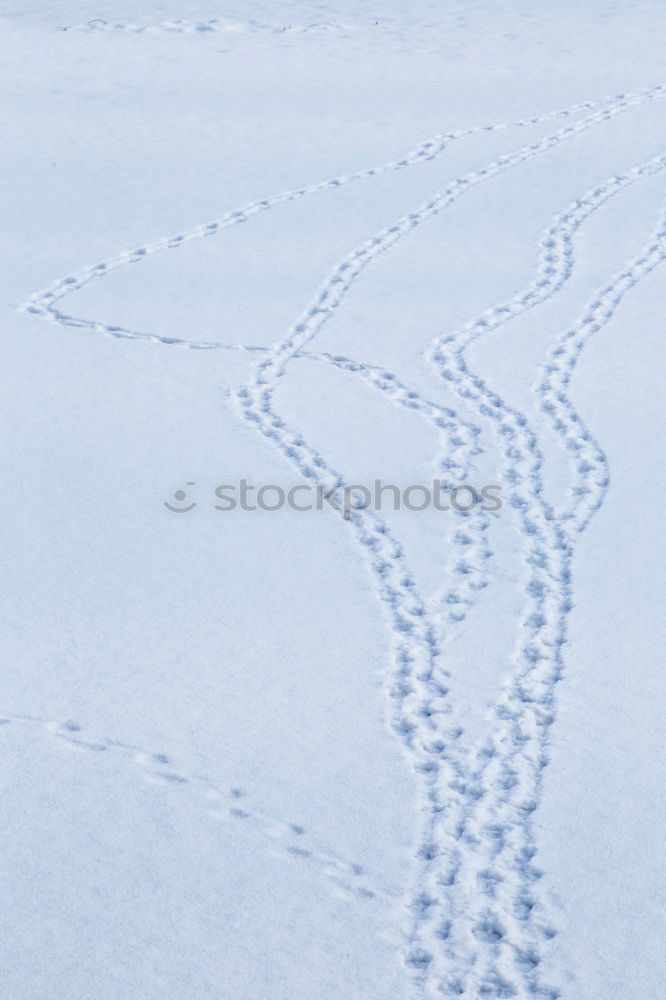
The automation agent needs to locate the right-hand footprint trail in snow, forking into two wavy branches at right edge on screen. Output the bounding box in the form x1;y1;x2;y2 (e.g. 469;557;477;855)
422;174;666;997
